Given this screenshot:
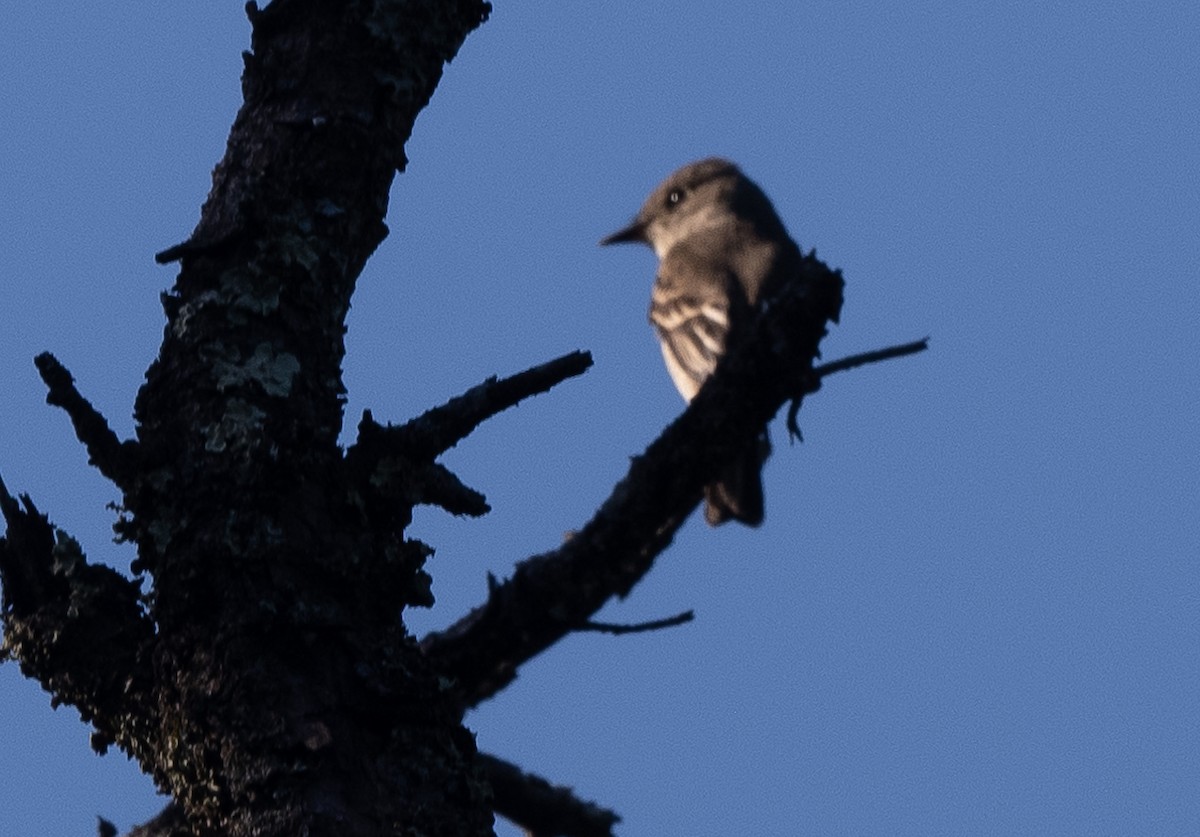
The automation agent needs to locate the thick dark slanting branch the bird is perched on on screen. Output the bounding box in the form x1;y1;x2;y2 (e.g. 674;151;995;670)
421;248;842;706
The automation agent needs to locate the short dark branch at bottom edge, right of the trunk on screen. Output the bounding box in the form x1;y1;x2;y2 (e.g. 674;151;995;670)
478;753;620;837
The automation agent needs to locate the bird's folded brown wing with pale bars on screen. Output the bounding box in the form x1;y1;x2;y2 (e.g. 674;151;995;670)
650;247;742;401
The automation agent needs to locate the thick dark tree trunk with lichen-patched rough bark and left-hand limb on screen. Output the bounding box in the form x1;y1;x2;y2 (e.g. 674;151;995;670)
4;0;492;836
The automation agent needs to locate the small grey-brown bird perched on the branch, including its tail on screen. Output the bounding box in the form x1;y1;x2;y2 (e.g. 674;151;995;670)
600;157;802;526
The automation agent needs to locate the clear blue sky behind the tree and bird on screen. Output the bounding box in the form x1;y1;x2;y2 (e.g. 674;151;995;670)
0;0;1200;837
